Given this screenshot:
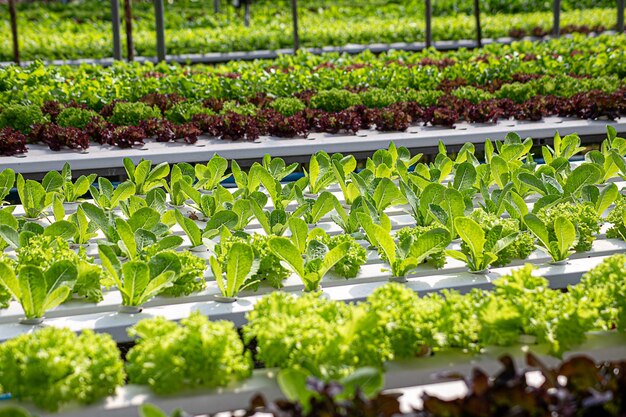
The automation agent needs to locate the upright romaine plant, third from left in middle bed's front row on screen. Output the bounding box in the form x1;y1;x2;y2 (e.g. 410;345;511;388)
209;242;260;297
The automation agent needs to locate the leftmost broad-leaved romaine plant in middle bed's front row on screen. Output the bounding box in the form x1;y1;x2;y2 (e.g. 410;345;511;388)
0;261;78;318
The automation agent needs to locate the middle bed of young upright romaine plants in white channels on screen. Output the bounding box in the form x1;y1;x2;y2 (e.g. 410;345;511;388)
0;127;626;319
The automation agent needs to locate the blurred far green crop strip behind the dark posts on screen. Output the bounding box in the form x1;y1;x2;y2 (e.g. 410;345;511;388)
0;1;616;61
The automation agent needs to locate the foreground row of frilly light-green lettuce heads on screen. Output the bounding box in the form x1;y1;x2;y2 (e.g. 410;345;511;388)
0;255;626;411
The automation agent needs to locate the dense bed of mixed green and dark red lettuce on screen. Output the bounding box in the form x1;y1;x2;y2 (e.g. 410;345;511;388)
0;36;626;151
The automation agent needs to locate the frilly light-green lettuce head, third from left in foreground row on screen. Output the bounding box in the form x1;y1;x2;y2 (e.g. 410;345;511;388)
243;290;392;380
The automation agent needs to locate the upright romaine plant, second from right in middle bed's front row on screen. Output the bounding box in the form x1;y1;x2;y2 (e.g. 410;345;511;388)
446;217;517;272
